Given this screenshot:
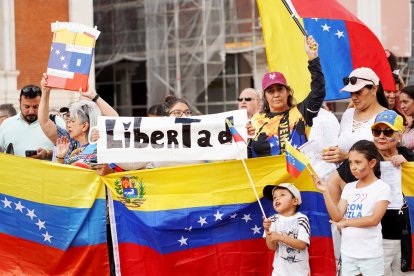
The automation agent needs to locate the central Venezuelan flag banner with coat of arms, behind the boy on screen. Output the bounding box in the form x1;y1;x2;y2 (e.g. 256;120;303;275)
103;156;335;276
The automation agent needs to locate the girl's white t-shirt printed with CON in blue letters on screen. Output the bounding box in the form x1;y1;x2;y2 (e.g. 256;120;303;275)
341;179;391;259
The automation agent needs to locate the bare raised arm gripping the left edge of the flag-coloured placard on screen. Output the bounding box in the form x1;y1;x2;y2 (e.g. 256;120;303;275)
37;74;58;145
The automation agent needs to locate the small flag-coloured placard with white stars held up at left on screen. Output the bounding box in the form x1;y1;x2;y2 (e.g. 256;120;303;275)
47;22;100;91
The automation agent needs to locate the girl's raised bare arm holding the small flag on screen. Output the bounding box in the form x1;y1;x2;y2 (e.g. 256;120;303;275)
312;175;348;222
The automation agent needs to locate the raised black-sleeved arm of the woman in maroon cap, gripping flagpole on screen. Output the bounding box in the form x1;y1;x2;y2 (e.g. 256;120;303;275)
298;36;326;126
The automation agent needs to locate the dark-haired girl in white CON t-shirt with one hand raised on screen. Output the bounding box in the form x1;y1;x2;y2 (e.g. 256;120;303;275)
313;140;391;276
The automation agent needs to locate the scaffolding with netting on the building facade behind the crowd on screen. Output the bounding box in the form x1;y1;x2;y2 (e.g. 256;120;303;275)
94;0;266;115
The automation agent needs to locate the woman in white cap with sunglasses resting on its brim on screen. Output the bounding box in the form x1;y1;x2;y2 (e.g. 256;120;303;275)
322;67;388;163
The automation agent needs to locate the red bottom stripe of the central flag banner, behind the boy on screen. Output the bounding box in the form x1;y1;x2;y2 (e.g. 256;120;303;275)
119;237;335;276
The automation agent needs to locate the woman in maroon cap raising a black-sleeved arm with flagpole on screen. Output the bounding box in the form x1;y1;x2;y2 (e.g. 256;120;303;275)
247;36;326;157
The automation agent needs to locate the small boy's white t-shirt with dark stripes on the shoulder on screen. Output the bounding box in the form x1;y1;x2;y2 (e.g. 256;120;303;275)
269;212;310;276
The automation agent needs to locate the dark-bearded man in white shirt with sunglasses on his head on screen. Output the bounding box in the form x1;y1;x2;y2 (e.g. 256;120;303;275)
0;85;64;160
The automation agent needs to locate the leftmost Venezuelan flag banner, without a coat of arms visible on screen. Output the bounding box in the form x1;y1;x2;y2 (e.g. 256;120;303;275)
0;154;109;275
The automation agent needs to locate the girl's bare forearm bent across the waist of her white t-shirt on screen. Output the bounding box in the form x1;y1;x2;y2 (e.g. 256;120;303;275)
333;200;389;229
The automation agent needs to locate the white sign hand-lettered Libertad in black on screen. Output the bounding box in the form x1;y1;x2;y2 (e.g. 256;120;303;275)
97;110;247;163
